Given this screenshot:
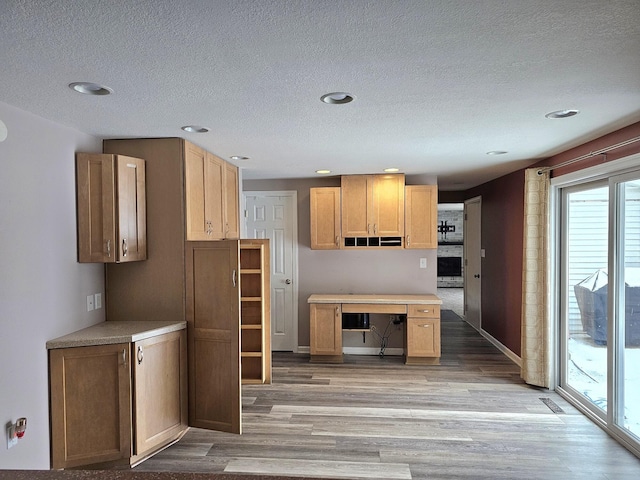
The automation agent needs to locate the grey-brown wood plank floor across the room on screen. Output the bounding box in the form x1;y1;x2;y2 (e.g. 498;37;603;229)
135;312;640;480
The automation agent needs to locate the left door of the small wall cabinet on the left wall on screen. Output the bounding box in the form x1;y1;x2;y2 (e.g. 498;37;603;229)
76;153;118;263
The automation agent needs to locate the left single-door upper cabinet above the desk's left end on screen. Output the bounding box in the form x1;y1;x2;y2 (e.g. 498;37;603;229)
309;187;341;250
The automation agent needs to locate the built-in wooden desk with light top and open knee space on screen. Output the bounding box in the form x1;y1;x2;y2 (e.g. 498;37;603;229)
307;294;442;365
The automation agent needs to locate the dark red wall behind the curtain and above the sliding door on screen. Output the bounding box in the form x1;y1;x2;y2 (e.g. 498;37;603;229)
465;122;640;355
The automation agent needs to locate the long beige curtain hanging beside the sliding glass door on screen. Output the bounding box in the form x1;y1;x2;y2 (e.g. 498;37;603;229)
521;168;550;388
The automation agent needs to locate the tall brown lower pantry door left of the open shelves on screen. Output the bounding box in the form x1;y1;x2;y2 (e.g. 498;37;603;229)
185;240;242;433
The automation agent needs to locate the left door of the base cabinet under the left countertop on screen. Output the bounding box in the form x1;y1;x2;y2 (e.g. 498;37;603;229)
49;343;131;469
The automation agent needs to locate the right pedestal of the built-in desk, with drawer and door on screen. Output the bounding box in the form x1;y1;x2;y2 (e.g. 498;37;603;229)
405;305;440;365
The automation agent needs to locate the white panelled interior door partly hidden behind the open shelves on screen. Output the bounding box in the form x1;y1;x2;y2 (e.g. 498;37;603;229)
243;192;298;352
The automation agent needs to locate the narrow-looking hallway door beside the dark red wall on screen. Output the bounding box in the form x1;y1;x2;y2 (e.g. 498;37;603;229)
464;197;482;330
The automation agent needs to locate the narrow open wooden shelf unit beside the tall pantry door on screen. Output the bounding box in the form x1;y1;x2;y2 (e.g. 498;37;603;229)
240;239;271;384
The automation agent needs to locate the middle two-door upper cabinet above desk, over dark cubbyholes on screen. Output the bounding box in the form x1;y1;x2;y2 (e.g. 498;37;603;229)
341;174;404;237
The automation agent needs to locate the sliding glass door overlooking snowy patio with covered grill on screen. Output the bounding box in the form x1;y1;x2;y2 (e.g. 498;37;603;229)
557;166;640;451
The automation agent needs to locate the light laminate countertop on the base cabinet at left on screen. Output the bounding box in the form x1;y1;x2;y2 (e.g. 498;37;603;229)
47;321;187;350
